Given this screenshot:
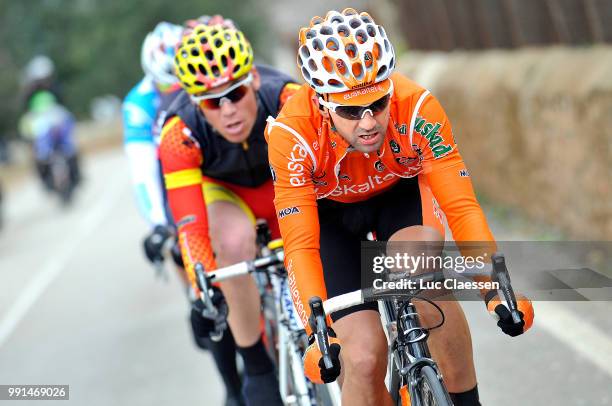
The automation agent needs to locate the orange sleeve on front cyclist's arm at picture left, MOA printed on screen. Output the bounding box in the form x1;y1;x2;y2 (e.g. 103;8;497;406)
266;118;327;332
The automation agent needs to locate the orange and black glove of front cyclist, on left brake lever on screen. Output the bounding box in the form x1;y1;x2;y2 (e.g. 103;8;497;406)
303;328;340;384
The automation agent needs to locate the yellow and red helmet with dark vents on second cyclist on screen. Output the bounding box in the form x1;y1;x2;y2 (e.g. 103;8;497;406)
174;24;253;94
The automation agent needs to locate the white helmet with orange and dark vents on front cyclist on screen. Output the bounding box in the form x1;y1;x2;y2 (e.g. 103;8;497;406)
297;8;395;93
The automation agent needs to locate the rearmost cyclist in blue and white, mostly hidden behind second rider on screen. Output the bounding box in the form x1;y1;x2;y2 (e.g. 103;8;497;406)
123;16;244;406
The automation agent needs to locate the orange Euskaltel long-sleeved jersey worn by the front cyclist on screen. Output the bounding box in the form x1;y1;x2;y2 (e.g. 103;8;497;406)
266;73;494;326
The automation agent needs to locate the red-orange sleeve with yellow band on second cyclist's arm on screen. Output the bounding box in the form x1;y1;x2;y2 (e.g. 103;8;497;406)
159;117;217;287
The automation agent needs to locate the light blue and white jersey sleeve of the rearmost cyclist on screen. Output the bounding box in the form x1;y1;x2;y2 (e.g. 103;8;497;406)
123;76;167;227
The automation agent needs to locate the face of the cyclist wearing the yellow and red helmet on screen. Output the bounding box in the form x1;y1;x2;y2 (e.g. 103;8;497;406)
200;68;261;143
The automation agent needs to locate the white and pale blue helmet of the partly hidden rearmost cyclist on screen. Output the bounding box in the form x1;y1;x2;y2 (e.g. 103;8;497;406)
140;21;183;85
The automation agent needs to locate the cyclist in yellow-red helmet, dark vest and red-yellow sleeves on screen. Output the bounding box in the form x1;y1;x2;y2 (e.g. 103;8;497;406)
159;16;298;406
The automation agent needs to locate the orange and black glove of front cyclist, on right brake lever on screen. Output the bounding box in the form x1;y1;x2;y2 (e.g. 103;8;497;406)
485;292;534;337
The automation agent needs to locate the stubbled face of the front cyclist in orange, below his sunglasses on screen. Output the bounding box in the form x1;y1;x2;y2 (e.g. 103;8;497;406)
323;103;390;153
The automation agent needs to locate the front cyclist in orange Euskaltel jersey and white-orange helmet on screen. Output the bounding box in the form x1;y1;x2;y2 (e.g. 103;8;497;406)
266;9;533;405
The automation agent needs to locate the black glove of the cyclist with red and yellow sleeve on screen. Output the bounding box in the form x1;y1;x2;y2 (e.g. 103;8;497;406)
190;287;229;338
